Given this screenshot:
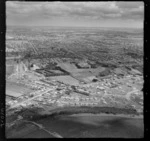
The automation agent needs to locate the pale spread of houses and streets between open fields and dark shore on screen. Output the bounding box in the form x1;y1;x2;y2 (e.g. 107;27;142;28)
6;59;142;117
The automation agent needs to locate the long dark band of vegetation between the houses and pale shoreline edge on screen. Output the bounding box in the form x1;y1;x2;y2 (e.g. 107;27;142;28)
16;106;139;121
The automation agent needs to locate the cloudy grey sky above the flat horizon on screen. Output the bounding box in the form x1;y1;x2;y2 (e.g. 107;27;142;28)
6;1;144;28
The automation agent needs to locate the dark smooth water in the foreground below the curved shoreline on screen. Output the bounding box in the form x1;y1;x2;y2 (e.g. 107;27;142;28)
23;114;144;138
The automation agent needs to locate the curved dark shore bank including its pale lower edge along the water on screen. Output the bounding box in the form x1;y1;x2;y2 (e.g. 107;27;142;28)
26;106;143;120
